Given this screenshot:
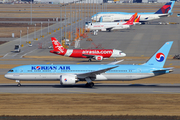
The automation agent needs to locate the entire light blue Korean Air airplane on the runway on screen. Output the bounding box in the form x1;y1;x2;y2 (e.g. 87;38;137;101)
5;41;173;87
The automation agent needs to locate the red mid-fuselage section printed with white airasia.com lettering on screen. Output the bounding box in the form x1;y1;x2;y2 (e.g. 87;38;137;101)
69;49;113;58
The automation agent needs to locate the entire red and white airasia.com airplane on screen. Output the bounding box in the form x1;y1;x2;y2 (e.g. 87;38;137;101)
50;37;126;62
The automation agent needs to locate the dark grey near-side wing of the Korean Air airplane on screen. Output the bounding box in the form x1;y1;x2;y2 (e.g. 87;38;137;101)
77;66;118;78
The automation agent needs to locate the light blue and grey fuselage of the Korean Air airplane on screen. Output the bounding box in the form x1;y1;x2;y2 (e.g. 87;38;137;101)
5;65;169;81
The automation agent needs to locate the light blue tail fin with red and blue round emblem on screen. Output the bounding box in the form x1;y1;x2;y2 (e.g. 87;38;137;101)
143;41;173;67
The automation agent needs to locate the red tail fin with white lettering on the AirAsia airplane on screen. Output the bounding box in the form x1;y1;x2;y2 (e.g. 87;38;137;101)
51;37;66;53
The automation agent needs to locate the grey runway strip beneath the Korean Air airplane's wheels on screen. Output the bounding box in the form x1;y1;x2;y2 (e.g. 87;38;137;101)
0;83;180;94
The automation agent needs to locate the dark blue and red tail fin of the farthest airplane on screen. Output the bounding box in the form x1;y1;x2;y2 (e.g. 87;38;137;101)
154;1;175;14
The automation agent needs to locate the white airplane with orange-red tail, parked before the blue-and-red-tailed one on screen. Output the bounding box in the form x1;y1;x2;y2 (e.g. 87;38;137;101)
85;13;137;32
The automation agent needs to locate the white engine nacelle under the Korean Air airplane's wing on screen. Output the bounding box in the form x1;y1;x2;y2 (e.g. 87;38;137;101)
60;75;78;85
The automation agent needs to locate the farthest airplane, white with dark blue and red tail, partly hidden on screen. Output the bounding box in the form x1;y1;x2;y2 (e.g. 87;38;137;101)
91;1;175;23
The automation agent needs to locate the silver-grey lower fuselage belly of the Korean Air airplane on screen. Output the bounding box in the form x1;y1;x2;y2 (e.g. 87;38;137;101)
5;73;155;81
